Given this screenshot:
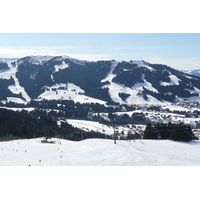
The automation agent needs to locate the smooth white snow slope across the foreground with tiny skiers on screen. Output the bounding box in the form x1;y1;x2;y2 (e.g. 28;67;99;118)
0;138;200;166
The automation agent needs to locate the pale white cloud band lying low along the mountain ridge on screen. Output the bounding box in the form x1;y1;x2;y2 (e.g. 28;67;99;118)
0;46;200;70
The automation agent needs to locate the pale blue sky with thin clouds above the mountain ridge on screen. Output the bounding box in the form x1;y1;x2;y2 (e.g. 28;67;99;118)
0;33;200;69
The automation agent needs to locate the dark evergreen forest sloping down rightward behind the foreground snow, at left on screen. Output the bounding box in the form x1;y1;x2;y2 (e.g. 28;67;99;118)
0;109;109;141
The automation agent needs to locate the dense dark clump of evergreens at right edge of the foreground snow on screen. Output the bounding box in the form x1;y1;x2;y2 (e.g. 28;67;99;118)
144;122;198;141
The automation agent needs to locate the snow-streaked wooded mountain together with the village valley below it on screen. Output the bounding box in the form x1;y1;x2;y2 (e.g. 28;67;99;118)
0;56;200;139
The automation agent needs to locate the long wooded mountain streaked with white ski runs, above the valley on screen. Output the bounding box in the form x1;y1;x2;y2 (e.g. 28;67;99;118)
0;56;200;104
